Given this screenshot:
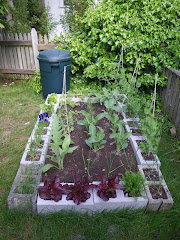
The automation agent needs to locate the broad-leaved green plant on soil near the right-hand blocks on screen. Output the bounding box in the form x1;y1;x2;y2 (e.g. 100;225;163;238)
109;124;131;152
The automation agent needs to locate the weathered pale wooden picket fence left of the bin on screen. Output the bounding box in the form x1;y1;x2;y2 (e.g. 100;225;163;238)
0;28;57;79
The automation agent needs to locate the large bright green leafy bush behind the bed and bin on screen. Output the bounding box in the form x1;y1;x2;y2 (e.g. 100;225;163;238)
56;0;180;88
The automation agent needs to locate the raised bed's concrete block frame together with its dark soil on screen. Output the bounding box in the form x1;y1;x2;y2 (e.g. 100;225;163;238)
8;95;172;213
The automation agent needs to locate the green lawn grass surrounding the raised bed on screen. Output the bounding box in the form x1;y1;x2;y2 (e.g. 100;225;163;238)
0;79;180;240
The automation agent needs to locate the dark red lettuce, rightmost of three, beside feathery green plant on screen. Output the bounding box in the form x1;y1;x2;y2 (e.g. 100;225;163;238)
95;175;124;201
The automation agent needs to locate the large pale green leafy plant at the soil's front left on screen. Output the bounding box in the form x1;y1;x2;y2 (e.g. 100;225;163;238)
42;135;78;173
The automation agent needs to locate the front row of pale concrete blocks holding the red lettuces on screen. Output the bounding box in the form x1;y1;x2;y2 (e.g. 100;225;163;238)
37;181;148;215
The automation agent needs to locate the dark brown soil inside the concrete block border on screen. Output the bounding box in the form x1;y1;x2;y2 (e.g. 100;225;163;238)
43;103;137;182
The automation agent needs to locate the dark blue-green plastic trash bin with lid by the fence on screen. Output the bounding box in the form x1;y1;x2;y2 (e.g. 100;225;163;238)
37;49;72;99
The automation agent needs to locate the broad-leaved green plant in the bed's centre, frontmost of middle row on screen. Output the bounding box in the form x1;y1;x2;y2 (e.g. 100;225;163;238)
85;123;106;152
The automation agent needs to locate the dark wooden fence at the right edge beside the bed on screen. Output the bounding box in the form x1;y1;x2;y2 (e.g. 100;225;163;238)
161;68;180;136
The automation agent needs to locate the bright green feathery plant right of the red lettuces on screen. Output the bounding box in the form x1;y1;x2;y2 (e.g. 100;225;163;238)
121;170;145;198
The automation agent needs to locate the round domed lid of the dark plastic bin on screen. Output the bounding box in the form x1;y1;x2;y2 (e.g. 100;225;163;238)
37;49;72;62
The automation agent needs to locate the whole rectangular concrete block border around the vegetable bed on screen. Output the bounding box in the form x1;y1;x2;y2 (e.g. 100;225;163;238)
8;94;173;214
